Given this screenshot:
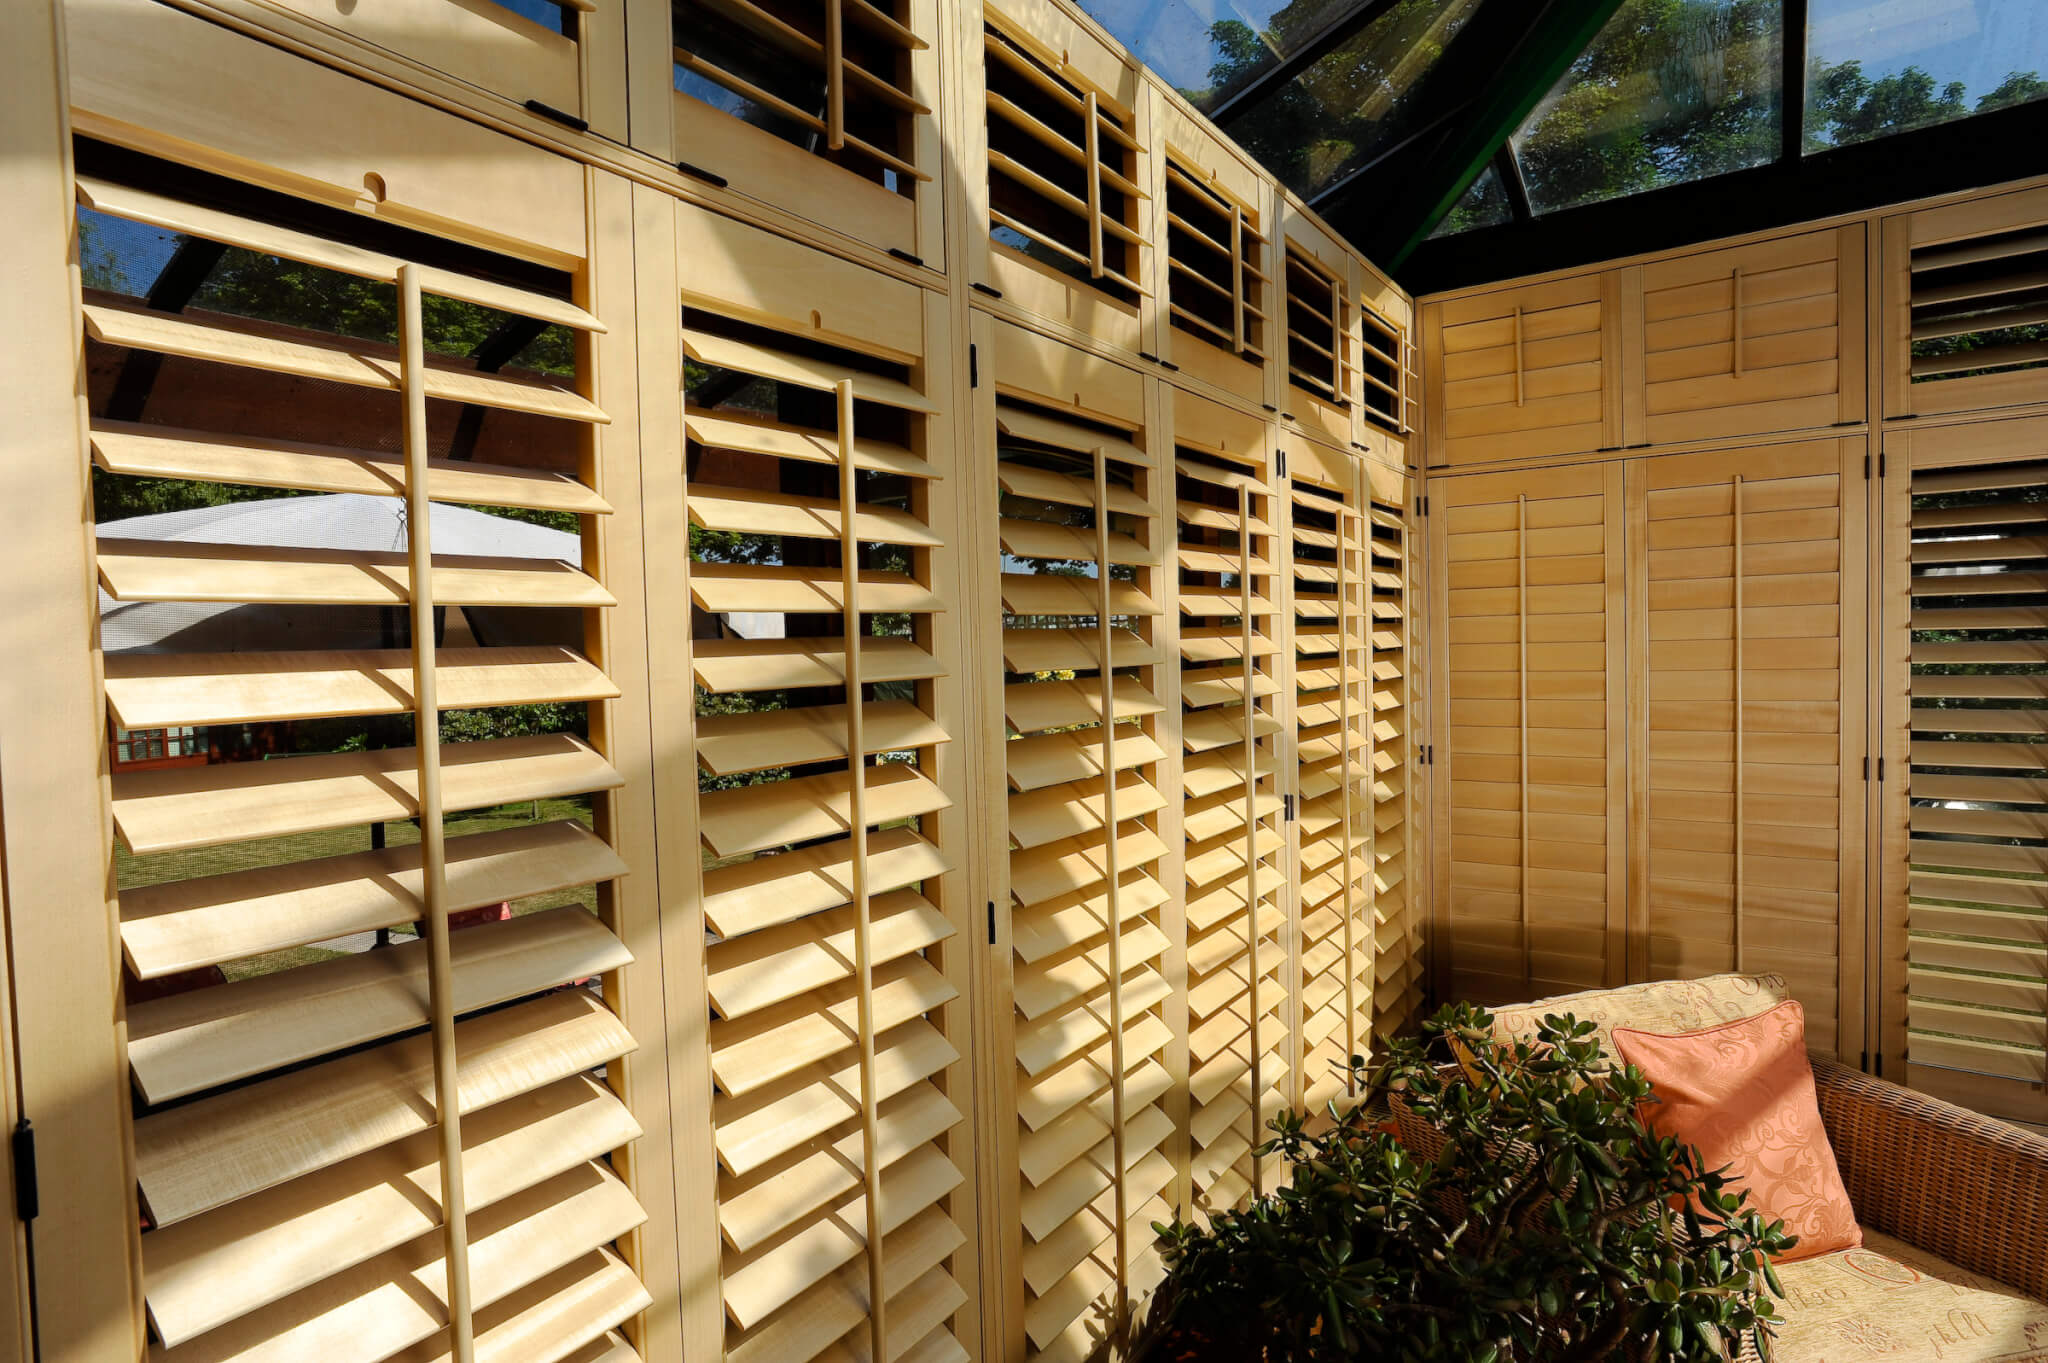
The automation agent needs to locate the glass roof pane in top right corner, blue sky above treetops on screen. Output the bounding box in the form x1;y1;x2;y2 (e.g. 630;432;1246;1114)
1806;0;2048;151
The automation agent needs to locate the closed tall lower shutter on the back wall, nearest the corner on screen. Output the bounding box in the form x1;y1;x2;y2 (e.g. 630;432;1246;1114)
1430;465;1626;1003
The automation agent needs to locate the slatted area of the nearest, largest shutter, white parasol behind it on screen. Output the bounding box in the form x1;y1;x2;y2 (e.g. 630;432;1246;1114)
80;166;649;1363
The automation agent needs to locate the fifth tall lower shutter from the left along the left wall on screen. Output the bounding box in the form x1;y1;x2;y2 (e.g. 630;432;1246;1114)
1288;466;1374;1107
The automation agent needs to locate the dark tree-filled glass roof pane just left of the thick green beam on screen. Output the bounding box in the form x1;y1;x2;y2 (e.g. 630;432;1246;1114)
1223;0;1479;199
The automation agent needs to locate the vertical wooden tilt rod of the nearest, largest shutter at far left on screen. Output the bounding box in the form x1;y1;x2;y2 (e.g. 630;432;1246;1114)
397;262;477;1363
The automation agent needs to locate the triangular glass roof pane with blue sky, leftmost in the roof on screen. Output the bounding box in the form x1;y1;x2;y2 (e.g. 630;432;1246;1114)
1081;0;1358;111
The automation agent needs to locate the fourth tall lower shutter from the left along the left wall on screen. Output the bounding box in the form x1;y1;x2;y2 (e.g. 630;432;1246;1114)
1174;397;1294;1212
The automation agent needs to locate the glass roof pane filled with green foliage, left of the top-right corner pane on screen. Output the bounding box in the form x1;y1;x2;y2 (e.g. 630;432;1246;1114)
1516;0;1784;213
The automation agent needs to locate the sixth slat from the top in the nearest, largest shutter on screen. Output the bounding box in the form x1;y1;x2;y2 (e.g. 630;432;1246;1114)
113;733;625;855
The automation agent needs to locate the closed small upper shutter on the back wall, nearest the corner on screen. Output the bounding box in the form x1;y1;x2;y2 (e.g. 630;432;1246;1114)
1423;274;1622;465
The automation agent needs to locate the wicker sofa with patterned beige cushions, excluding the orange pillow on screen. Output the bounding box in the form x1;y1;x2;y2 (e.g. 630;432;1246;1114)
1497;976;2048;1363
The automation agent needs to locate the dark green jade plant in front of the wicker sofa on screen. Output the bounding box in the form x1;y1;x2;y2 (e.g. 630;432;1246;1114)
1155;1005;1794;1363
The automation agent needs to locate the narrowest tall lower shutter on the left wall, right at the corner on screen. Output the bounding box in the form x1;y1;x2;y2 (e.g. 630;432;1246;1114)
1366;467;1423;1038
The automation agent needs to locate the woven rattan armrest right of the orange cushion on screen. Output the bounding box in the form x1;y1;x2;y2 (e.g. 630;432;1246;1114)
1812;1060;2048;1300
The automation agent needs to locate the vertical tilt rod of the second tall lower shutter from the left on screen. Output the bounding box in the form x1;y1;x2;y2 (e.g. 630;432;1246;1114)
831;374;889;1359
